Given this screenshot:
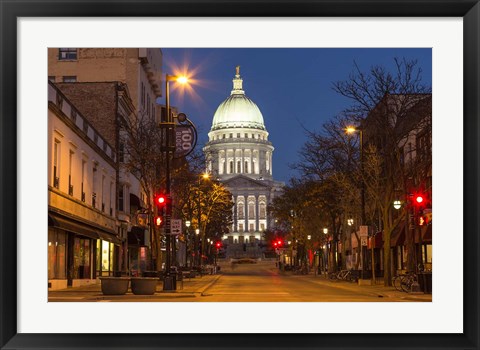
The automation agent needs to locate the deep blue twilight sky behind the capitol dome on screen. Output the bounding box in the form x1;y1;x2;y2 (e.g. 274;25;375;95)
160;48;432;182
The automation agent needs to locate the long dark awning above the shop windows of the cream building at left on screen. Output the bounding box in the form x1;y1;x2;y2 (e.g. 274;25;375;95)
48;212;122;244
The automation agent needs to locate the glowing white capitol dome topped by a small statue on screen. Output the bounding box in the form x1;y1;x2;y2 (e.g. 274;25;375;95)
211;67;265;131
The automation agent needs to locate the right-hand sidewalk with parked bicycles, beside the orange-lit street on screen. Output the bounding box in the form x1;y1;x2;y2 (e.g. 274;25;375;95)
285;272;432;302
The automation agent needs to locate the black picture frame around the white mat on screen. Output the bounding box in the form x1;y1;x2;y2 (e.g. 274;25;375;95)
0;0;480;349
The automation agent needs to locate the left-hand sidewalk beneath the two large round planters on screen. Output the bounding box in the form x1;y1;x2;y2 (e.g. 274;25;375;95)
48;275;221;301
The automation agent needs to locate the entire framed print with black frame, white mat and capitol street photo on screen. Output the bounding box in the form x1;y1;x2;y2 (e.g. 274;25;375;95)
0;0;480;349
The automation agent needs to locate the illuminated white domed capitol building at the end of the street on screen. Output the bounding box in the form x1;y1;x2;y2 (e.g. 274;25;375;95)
203;66;283;256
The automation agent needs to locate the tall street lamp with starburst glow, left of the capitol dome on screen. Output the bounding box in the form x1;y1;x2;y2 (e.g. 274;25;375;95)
163;74;188;290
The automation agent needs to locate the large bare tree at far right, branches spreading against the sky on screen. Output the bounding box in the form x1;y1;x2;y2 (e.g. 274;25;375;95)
333;59;431;285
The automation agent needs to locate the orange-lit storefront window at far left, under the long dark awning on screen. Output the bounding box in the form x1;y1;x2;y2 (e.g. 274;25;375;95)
48;230;67;279
